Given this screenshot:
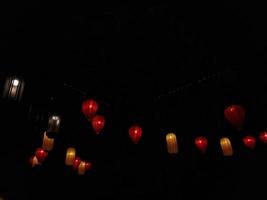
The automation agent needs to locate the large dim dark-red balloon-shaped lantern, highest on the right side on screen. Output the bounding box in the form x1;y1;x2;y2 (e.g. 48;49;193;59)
224;105;246;130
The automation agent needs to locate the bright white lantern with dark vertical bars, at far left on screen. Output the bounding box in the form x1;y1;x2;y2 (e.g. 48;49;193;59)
3;77;24;100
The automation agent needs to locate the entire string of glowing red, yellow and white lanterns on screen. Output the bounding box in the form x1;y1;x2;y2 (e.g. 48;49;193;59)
3;77;267;175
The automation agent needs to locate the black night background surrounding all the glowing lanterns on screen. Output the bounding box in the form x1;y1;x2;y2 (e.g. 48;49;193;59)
0;2;267;199
